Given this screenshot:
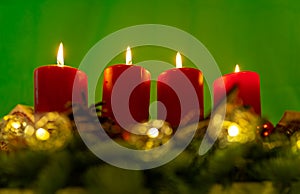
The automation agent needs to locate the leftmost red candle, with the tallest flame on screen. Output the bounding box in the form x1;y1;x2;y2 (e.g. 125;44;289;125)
34;43;87;113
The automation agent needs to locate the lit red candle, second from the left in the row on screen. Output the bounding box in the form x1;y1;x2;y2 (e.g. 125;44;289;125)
102;47;151;128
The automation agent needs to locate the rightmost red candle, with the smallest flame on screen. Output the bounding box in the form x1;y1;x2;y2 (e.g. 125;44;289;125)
213;65;261;115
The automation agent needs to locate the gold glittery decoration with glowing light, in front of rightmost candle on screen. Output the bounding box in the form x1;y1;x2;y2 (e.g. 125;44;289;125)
203;87;261;147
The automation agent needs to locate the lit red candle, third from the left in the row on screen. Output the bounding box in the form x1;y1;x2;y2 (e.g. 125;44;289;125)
157;53;204;128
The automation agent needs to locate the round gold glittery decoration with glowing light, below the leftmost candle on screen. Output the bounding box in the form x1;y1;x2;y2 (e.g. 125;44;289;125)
25;112;72;151
